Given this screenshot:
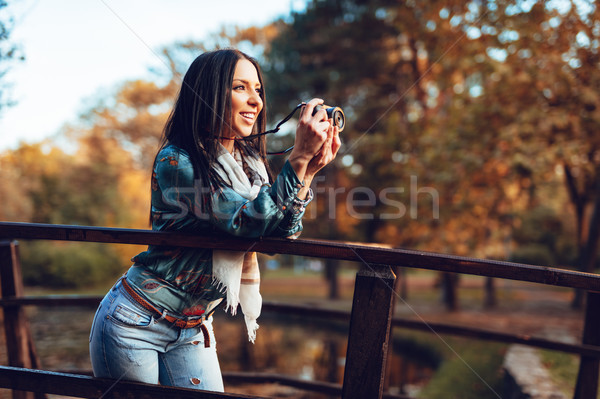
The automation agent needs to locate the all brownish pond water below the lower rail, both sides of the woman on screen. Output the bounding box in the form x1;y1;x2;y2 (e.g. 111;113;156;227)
27;307;439;393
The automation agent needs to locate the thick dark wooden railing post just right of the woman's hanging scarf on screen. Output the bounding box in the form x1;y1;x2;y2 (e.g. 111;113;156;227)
342;264;395;399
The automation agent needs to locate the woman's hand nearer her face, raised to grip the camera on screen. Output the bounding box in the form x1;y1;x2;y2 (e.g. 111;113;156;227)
289;98;331;180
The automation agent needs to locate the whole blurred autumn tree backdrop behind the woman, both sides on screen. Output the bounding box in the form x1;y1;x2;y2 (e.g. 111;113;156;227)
0;0;600;307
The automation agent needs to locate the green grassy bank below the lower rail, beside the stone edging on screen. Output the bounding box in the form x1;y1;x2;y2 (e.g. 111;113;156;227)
419;342;505;399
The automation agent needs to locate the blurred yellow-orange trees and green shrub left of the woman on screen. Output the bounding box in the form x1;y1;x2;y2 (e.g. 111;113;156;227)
0;34;264;287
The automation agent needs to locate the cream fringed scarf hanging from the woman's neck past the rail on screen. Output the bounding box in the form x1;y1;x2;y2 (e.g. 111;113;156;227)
212;147;269;343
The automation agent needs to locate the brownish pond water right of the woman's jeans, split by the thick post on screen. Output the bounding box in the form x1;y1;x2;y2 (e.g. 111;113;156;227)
215;315;439;390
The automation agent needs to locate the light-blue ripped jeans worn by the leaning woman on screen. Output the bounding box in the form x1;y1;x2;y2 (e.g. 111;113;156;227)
90;280;224;392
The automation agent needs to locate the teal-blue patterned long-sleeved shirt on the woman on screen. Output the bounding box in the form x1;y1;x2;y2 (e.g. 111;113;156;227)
127;145;310;316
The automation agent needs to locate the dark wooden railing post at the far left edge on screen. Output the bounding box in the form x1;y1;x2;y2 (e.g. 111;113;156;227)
0;241;37;399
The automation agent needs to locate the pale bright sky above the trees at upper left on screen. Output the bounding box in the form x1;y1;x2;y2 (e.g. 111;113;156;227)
0;0;305;152
